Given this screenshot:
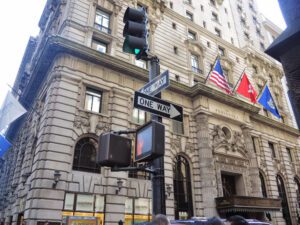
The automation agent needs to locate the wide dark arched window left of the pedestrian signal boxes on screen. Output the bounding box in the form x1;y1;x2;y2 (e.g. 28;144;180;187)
73;137;100;173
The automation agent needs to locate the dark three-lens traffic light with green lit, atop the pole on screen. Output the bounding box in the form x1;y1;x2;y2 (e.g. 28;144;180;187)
123;7;148;59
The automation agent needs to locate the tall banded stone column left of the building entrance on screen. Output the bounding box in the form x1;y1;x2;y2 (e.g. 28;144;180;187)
196;113;218;217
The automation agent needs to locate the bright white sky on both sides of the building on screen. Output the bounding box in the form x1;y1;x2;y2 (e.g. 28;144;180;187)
0;0;285;108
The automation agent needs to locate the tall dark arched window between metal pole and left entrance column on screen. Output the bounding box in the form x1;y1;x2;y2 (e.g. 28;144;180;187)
173;155;193;219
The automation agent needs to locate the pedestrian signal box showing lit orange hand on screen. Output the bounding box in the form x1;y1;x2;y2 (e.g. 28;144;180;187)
135;121;165;162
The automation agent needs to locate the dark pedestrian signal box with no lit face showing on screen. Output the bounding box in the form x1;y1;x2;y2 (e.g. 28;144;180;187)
97;133;131;167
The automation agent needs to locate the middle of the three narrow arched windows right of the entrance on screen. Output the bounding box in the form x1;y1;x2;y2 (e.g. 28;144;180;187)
276;175;292;225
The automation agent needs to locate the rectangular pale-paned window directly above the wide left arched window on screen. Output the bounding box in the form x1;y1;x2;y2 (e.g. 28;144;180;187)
84;88;102;113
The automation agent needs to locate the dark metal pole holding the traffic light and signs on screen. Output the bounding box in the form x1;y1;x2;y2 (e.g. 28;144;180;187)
149;56;166;216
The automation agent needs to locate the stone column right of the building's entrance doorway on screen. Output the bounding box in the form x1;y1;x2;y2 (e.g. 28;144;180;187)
241;125;262;197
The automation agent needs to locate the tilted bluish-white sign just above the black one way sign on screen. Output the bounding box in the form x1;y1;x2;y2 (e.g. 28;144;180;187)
139;70;170;96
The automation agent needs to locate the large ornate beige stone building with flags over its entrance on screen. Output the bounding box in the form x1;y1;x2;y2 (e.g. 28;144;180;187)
0;0;300;225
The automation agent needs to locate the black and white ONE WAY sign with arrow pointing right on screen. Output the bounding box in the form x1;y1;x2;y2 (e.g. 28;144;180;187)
134;91;183;122
